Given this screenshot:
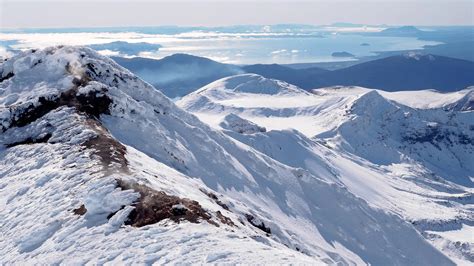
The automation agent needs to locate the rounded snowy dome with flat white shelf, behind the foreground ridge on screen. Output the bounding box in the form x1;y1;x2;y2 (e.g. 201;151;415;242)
177;74;348;135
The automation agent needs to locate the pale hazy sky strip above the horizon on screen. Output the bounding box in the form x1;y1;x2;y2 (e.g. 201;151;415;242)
0;0;474;28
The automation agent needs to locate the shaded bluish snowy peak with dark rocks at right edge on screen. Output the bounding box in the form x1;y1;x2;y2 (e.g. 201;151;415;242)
326;91;474;187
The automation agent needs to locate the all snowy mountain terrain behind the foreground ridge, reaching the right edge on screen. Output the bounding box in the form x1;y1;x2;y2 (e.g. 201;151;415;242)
178;75;474;264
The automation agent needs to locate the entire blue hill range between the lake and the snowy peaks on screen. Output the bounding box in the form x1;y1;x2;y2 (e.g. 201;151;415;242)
113;53;474;98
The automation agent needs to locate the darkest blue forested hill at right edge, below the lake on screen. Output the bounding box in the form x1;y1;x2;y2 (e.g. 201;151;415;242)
316;54;474;92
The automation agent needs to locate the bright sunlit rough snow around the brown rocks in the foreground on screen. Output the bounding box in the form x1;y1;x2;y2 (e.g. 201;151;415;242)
0;112;315;264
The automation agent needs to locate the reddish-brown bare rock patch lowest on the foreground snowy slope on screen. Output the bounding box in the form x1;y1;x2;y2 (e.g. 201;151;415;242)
117;180;217;227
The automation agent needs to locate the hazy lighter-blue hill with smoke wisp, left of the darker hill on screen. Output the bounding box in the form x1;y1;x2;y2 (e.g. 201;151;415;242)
113;54;329;98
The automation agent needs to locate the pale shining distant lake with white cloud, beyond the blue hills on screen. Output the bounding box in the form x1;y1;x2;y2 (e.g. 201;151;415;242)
0;29;440;64
